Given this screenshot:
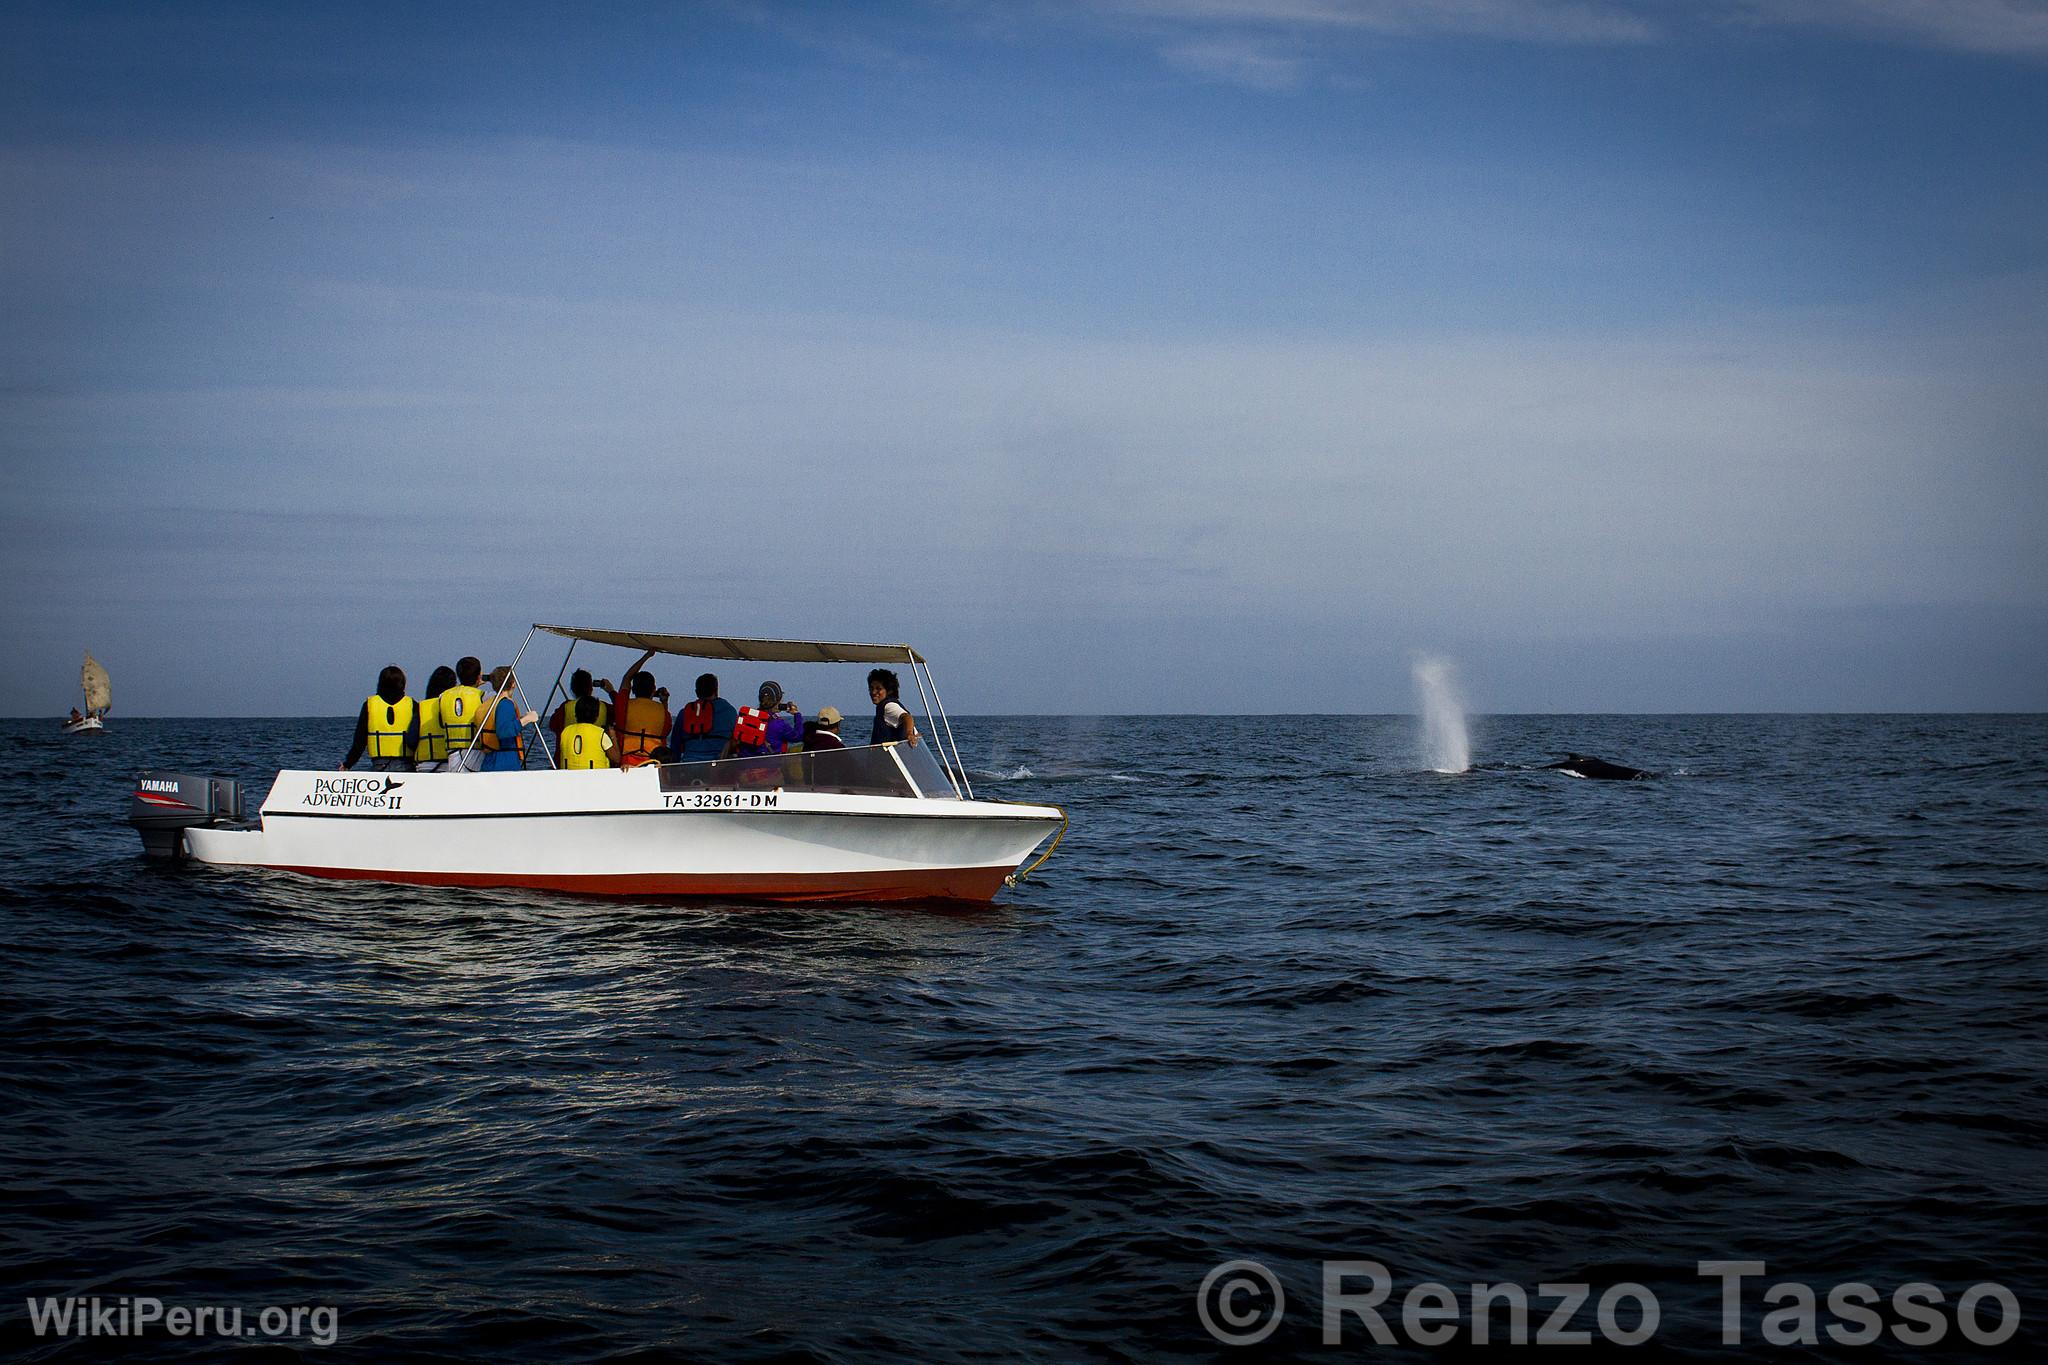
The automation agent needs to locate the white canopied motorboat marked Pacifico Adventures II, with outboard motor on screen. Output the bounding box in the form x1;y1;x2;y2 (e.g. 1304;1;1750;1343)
129;626;1067;900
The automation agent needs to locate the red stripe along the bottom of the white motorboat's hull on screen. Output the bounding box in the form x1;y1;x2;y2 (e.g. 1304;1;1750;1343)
258;864;1010;900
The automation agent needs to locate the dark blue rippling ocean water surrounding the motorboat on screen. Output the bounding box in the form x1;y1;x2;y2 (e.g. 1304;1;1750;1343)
0;716;2048;1363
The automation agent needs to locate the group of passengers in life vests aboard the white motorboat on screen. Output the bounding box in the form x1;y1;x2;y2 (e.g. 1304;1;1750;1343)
342;655;918;772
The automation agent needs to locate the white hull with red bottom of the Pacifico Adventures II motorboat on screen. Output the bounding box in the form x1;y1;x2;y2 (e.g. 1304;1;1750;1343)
184;767;1065;900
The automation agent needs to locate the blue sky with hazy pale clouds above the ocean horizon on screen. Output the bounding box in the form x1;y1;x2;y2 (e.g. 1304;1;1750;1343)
0;0;2048;714
